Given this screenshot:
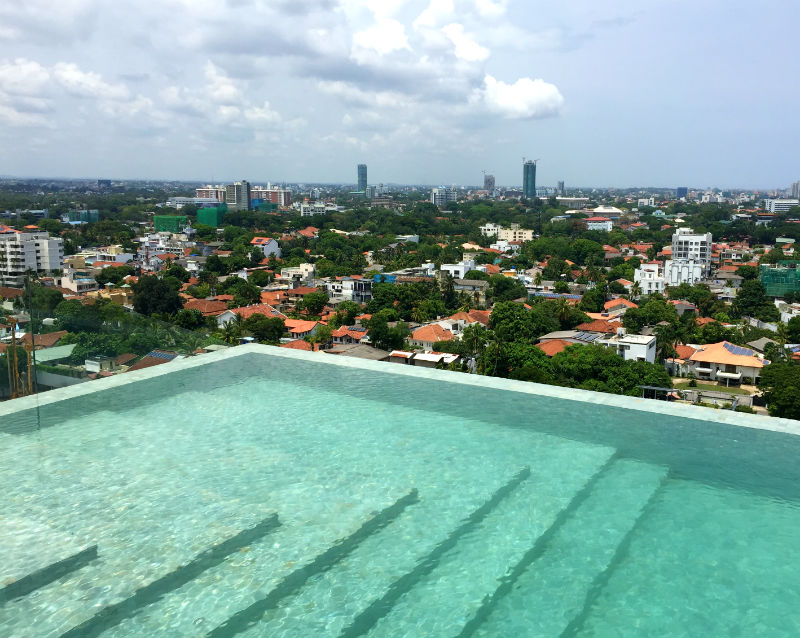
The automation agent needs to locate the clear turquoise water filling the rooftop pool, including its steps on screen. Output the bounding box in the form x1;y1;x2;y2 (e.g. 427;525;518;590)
0;349;800;638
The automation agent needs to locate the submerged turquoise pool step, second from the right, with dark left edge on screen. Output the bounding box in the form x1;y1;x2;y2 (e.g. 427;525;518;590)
340;456;614;638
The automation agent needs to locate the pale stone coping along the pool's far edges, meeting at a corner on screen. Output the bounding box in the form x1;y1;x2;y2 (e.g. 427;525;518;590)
0;344;800;435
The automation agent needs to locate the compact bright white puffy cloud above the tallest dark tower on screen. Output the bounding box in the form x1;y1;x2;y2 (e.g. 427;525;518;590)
472;74;564;119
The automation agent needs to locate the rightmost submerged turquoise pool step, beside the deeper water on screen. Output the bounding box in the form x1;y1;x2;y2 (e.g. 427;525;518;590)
468;459;667;638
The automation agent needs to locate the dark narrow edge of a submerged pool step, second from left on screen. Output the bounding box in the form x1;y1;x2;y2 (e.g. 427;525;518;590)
61;514;280;638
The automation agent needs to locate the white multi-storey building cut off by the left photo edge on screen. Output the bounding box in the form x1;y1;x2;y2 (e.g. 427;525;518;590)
0;226;64;286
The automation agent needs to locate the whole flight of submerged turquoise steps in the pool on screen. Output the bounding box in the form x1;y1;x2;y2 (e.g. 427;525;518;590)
0;445;667;638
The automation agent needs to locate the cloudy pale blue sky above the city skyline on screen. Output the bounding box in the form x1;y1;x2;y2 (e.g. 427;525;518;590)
0;0;800;189
